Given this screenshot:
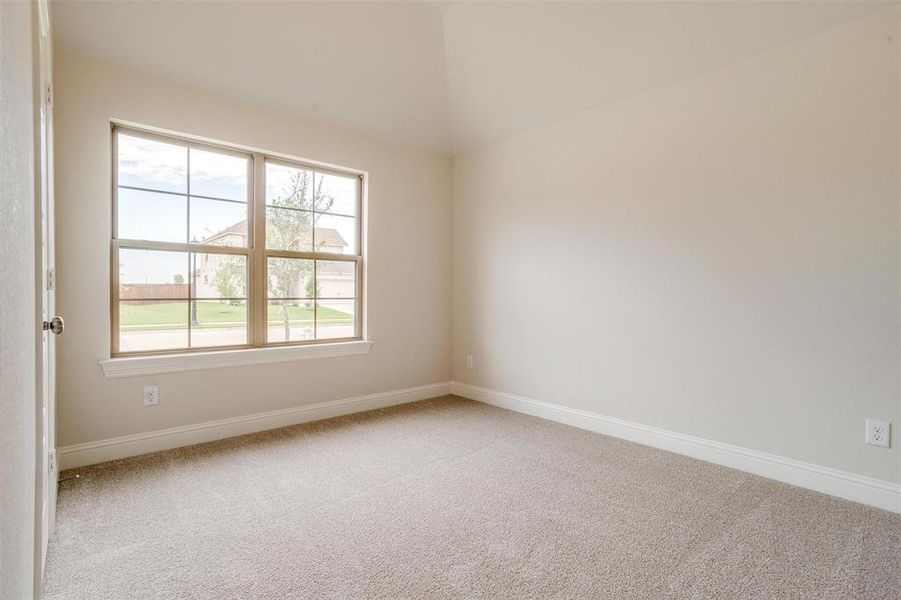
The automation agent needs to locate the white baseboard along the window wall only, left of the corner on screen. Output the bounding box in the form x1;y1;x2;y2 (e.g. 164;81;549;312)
57;382;450;470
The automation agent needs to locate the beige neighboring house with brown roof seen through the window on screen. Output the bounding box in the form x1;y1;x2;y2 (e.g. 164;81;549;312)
191;221;356;302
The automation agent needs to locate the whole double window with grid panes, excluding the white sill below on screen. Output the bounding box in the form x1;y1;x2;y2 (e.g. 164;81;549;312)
111;126;363;356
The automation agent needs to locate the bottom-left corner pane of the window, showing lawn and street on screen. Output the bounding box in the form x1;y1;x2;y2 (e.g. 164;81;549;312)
119;300;188;352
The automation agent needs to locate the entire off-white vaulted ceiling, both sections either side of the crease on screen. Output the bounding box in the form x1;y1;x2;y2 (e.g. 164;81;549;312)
53;0;894;153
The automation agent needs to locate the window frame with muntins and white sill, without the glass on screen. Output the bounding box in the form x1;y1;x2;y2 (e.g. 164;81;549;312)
110;122;371;360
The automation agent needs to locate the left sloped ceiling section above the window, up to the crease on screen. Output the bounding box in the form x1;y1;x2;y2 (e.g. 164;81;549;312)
51;0;449;150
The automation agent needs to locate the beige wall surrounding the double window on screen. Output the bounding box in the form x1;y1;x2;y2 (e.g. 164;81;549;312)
55;52;451;446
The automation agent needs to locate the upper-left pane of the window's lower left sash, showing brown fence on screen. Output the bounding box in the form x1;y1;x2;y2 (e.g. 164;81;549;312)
119;248;188;300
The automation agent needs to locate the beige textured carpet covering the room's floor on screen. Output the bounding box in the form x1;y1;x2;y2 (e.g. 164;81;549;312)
45;398;901;599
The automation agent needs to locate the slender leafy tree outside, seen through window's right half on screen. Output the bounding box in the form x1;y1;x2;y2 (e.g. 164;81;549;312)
266;171;335;340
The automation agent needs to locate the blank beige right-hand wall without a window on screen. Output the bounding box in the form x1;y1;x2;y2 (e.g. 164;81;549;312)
452;12;901;481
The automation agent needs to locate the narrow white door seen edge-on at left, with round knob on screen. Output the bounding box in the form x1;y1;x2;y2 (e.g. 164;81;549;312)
37;0;57;575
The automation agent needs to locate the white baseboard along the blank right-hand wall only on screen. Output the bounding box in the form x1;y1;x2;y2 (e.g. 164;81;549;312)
451;381;901;513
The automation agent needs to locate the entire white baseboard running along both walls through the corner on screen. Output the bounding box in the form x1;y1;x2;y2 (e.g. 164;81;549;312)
57;381;901;513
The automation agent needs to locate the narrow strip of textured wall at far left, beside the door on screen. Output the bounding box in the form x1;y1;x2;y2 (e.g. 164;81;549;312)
0;2;37;600
